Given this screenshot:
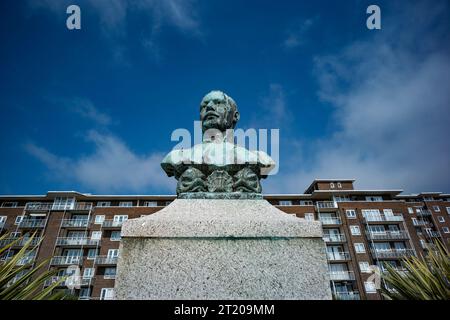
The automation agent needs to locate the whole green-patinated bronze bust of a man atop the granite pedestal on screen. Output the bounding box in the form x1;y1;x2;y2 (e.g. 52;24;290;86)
161;91;275;198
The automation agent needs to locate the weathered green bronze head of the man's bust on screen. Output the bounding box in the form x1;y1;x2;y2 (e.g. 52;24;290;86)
200;91;239;132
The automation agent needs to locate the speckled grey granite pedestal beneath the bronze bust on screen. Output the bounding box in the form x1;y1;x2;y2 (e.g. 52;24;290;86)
115;199;331;299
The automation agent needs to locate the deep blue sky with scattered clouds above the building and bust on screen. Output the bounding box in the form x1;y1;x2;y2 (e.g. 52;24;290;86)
0;0;450;194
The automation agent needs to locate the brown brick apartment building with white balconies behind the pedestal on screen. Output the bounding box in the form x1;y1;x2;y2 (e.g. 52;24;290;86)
0;179;450;300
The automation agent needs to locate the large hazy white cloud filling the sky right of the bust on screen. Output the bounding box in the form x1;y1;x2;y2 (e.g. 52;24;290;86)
265;2;450;193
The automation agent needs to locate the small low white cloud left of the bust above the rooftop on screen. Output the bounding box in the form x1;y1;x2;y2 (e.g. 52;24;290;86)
25;131;175;193
